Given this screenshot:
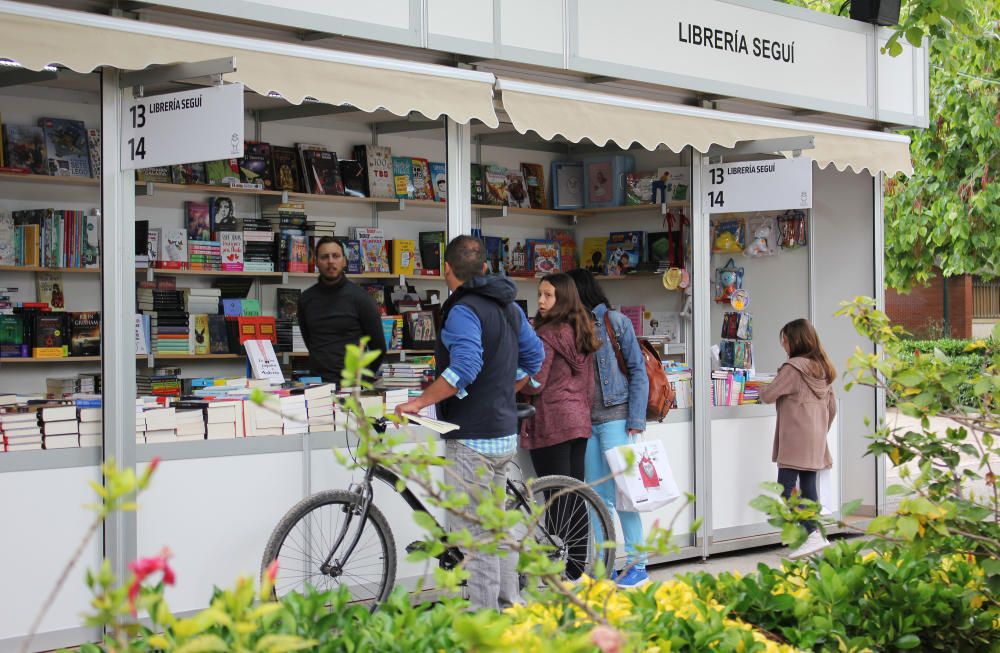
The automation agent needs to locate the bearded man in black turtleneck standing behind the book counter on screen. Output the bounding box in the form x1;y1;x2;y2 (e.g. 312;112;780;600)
298;236;385;384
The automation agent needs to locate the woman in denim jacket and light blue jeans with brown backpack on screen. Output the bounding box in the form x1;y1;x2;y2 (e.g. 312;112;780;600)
568;268;649;587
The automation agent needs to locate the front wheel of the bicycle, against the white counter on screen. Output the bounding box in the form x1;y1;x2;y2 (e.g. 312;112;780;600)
261;490;396;608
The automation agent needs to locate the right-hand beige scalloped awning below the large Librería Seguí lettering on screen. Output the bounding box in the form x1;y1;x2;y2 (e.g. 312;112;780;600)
497;79;913;176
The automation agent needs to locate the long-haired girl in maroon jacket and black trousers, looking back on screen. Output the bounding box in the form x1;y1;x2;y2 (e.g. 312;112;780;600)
521;273;600;481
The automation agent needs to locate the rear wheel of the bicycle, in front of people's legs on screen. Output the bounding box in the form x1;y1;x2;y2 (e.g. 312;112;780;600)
528;476;615;580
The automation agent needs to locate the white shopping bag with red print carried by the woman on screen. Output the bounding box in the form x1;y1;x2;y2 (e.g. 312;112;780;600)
604;440;681;512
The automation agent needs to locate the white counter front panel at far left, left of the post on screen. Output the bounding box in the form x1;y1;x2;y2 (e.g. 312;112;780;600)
0;466;103;650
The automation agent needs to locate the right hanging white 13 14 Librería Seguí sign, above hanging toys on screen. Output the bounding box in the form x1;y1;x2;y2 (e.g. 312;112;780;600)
701;157;812;213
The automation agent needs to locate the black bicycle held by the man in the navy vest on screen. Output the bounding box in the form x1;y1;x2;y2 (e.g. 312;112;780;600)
261;404;615;609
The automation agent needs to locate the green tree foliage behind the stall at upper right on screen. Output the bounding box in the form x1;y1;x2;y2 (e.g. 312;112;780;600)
788;0;1000;290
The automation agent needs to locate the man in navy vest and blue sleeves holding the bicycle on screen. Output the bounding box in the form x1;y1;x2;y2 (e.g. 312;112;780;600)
396;236;545;609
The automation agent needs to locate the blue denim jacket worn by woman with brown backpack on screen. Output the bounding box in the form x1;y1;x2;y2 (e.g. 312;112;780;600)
593;304;649;431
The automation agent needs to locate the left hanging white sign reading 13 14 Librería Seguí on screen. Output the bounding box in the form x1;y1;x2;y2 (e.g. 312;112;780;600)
121;84;244;170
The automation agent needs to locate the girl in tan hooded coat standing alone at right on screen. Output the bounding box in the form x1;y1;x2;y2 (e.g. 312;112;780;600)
760;319;837;558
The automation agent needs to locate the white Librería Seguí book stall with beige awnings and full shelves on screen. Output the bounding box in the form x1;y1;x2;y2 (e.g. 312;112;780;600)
0;0;926;651
